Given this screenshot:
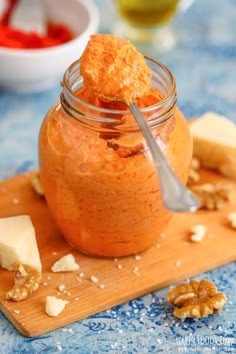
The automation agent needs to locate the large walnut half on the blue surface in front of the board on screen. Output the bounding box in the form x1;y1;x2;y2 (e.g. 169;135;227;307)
167;279;227;319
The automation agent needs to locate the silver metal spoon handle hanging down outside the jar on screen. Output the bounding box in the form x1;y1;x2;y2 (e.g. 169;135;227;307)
127;103;199;212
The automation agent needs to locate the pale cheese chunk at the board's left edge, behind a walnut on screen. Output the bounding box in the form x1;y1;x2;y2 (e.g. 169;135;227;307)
0;215;42;272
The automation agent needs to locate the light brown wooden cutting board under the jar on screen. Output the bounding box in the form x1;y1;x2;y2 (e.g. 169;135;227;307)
0;171;236;337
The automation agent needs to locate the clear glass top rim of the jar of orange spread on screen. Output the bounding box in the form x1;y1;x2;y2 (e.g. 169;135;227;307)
61;56;177;114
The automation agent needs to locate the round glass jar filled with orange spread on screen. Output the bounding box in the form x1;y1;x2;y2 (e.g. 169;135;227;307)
39;58;192;257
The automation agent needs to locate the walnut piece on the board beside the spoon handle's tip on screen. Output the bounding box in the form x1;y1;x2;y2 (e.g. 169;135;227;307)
190;183;235;210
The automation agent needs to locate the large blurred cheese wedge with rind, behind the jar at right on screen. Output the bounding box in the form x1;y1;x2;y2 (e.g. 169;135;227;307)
190;112;236;179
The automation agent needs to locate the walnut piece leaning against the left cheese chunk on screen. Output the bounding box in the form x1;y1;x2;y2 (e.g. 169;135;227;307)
6;264;41;301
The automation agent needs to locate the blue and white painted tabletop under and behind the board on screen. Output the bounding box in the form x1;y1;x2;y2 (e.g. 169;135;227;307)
0;0;236;354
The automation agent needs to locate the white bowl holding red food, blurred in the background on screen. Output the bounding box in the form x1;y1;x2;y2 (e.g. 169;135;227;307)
0;0;99;92
